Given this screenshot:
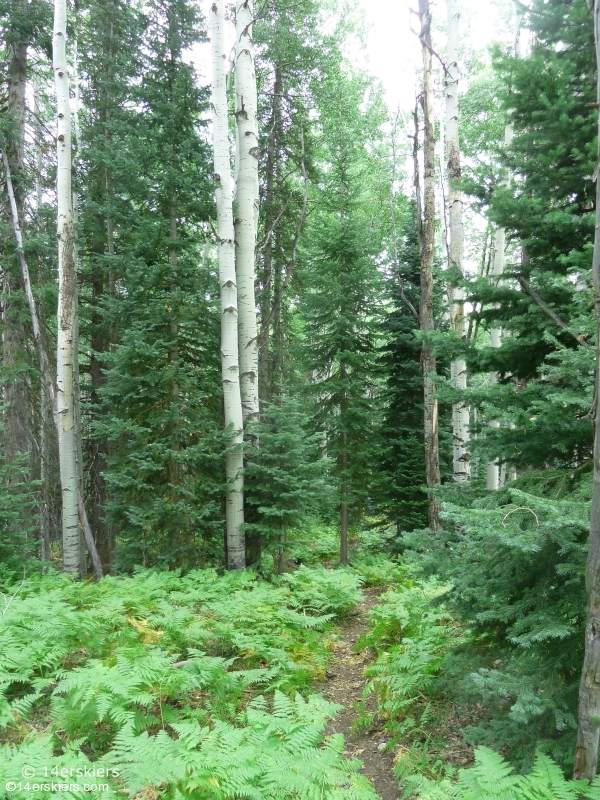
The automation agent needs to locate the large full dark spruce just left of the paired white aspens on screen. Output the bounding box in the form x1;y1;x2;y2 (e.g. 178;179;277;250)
95;1;223;566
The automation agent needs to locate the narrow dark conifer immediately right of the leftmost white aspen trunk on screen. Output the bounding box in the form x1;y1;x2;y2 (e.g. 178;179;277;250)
77;0;144;569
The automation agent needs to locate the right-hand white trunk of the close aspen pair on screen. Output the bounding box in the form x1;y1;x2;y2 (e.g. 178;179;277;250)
235;0;259;434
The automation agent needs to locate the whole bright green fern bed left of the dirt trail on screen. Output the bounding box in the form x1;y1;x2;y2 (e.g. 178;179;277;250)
0;567;376;800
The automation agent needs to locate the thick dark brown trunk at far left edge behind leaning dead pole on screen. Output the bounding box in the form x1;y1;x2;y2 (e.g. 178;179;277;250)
2;7;30;476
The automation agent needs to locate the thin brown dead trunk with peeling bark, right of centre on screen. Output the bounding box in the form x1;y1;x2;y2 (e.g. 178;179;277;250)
413;0;442;533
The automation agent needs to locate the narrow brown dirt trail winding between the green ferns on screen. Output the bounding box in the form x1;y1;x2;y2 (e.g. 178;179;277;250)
321;589;400;800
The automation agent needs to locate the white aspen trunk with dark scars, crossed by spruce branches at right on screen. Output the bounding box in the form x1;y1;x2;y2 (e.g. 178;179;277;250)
446;0;471;483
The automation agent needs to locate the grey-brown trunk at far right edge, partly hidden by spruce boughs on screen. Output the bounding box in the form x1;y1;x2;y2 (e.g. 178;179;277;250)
573;0;600;781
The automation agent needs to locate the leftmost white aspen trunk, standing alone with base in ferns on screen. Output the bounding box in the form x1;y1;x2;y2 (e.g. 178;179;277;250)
52;0;82;575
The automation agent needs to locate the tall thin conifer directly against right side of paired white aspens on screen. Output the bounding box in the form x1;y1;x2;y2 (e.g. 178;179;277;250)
254;0;328;404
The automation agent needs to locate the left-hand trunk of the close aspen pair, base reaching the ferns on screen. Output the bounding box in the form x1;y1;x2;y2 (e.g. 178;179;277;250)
209;0;246;569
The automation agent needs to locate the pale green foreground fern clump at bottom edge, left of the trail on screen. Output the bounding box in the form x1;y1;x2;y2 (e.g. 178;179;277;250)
109;693;377;800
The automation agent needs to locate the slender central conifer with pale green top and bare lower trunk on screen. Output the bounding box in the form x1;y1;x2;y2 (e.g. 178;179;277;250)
304;74;380;564
